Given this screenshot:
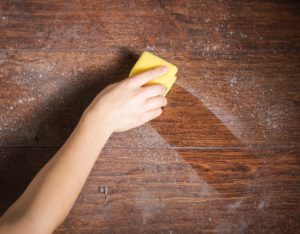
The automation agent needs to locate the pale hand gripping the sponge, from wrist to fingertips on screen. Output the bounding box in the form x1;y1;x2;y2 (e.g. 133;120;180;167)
85;66;168;132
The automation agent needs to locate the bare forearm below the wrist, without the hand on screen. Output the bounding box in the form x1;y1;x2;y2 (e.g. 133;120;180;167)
3;113;111;231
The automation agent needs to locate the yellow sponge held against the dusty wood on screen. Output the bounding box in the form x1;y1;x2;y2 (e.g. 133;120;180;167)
129;51;178;96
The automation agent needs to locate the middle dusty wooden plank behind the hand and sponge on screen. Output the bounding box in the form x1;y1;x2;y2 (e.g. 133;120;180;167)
0;50;300;147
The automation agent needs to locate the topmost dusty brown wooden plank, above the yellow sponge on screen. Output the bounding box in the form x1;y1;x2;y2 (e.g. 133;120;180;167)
0;0;300;51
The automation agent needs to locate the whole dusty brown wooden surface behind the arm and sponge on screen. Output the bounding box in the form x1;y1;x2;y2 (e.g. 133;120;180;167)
0;0;300;234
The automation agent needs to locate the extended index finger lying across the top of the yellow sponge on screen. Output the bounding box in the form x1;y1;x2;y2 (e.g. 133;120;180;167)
130;66;168;87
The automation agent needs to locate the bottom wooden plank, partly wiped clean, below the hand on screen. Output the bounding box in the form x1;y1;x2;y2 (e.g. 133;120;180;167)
0;146;300;233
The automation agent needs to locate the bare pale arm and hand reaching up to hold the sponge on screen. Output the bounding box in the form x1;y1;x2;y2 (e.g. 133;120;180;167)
0;66;168;234
